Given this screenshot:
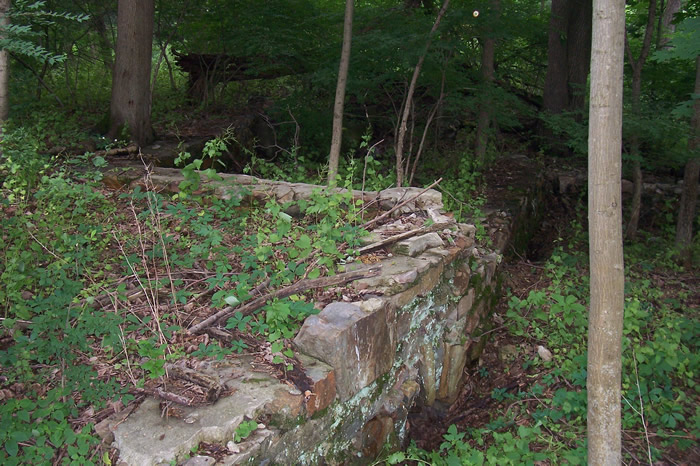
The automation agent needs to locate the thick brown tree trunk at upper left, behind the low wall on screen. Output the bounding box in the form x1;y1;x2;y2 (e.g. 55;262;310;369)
108;0;155;146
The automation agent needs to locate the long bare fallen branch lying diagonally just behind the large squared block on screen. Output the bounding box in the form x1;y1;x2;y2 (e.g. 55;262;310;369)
187;266;381;334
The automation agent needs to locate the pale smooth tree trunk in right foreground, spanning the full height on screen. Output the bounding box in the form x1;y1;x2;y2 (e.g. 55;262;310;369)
587;0;625;465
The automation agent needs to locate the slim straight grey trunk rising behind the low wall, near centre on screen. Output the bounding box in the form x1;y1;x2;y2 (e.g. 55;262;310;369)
328;0;354;186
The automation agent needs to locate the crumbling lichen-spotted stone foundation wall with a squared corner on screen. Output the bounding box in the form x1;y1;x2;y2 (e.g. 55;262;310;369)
100;157;536;465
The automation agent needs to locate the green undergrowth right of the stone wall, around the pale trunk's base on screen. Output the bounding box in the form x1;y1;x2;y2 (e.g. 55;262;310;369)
382;217;700;465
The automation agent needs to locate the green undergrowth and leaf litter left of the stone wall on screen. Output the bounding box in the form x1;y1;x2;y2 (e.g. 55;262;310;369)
0;126;364;464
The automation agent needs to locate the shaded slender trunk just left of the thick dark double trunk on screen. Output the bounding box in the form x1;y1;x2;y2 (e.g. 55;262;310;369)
474;0;500;163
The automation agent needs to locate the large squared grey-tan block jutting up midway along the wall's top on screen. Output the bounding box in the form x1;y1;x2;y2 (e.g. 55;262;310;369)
294;303;395;400
